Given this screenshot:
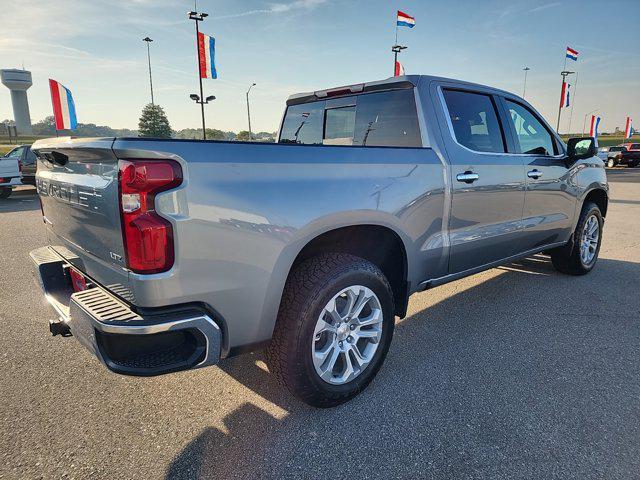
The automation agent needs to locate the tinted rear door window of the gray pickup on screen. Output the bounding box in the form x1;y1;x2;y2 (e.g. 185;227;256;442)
443;90;506;153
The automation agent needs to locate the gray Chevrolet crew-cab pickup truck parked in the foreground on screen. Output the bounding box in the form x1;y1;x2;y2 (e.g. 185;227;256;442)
31;76;608;407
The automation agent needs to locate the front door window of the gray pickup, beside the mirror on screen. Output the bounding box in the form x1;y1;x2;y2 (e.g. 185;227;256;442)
507;100;555;155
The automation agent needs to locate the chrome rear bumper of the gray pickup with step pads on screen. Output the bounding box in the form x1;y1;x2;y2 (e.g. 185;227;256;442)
30;247;221;376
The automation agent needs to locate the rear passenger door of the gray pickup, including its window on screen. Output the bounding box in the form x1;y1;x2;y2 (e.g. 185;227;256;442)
436;86;525;273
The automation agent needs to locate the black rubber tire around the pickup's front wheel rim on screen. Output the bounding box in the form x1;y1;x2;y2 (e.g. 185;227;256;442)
551;202;604;275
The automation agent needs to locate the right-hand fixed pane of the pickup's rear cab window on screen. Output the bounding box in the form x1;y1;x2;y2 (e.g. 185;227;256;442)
353;90;422;147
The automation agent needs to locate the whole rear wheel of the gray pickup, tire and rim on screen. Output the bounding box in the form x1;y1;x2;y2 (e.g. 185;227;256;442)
266;253;395;407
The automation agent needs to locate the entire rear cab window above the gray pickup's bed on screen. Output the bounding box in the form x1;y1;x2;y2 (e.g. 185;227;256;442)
279;89;422;147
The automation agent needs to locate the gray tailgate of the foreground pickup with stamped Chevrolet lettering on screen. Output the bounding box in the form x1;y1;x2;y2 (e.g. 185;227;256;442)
32;138;128;297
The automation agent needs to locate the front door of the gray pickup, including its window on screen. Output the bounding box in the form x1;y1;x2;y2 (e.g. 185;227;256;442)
503;98;578;250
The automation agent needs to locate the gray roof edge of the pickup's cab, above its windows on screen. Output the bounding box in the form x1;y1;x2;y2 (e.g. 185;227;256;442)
287;75;517;105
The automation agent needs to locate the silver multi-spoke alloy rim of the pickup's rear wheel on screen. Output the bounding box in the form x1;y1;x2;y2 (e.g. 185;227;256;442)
311;285;383;385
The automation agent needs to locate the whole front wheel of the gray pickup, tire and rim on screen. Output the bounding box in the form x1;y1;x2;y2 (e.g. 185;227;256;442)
551;202;604;275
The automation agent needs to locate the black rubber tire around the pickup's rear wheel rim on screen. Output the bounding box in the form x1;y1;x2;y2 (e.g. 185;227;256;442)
266;253;395;408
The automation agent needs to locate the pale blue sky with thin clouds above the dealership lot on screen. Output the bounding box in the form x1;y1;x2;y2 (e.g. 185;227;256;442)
0;0;640;133
